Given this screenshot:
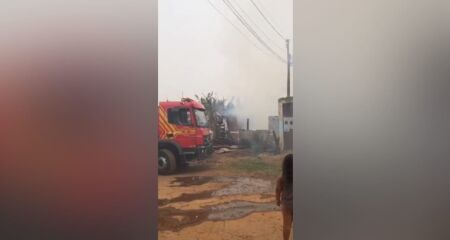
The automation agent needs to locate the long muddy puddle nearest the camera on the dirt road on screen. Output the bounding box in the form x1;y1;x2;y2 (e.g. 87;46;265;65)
158;201;279;231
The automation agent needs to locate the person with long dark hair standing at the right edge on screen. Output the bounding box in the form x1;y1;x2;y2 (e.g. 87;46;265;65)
276;154;293;240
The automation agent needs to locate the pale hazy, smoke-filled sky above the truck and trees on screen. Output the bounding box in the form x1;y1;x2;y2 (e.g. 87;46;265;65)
158;0;292;129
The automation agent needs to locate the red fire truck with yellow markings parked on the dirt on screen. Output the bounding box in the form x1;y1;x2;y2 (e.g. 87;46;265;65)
158;98;212;174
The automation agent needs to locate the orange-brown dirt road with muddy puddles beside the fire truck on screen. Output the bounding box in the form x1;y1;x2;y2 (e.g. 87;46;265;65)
158;150;290;240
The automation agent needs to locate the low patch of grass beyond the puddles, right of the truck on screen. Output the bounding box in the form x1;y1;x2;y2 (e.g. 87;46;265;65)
229;158;281;176
